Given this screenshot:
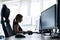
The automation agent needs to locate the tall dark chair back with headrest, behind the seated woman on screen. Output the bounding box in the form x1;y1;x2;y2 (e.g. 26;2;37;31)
1;4;12;37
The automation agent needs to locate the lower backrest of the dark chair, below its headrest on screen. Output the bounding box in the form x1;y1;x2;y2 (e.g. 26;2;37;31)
2;20;15;37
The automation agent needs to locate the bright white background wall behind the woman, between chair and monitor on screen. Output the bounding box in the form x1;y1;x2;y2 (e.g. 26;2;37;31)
3;0;42;30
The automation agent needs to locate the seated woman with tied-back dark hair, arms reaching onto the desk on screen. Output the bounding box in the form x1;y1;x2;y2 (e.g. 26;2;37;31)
13;14;32;37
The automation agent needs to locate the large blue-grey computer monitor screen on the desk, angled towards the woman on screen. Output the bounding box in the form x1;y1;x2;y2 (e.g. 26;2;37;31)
41;4;56;29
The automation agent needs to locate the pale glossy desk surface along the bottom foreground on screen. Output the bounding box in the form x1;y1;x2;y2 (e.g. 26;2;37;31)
1;34;60;40
